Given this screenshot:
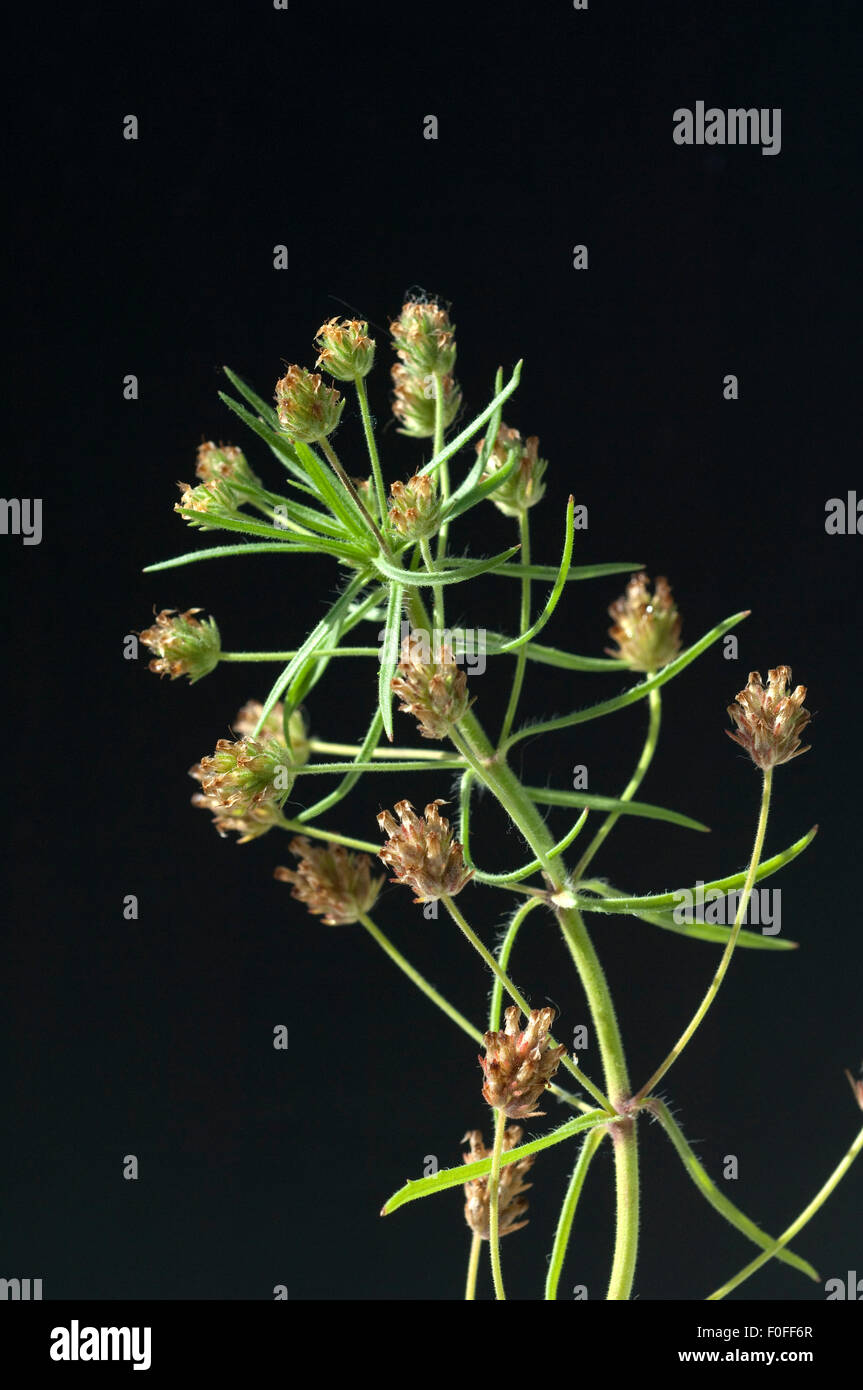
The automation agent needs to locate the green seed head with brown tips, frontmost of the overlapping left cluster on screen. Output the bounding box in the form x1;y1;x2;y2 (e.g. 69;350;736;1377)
189;737;297;816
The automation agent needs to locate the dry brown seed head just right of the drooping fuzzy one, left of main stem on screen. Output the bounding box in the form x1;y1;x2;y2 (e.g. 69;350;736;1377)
378;799;474;902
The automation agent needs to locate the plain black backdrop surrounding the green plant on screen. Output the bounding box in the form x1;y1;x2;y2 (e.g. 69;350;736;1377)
0;0;863;1300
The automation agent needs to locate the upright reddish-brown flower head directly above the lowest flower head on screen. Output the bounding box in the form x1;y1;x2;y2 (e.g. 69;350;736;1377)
479;1004;566;1120
